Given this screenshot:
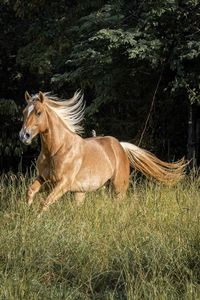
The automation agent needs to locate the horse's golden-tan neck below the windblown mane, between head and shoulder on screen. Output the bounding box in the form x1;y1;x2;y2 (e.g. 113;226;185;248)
40;108;78;156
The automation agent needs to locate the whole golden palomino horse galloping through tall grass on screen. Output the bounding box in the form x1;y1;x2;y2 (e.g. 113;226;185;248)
19;92;185;211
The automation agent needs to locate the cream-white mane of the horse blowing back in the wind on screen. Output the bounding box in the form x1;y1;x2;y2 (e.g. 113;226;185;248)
38;91;85;134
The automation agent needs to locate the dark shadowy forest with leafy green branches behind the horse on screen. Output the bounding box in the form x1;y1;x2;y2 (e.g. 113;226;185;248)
0;0;200;171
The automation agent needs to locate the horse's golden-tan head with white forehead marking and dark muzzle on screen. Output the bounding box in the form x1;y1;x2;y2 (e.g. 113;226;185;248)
19;92;47;145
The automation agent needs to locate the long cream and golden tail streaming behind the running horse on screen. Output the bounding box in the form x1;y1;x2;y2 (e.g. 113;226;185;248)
120;142;187;184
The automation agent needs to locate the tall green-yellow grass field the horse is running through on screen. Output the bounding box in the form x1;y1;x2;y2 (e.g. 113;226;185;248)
0;174;200;300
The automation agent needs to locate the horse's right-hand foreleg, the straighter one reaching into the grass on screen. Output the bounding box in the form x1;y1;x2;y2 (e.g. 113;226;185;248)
40;180;69;214
